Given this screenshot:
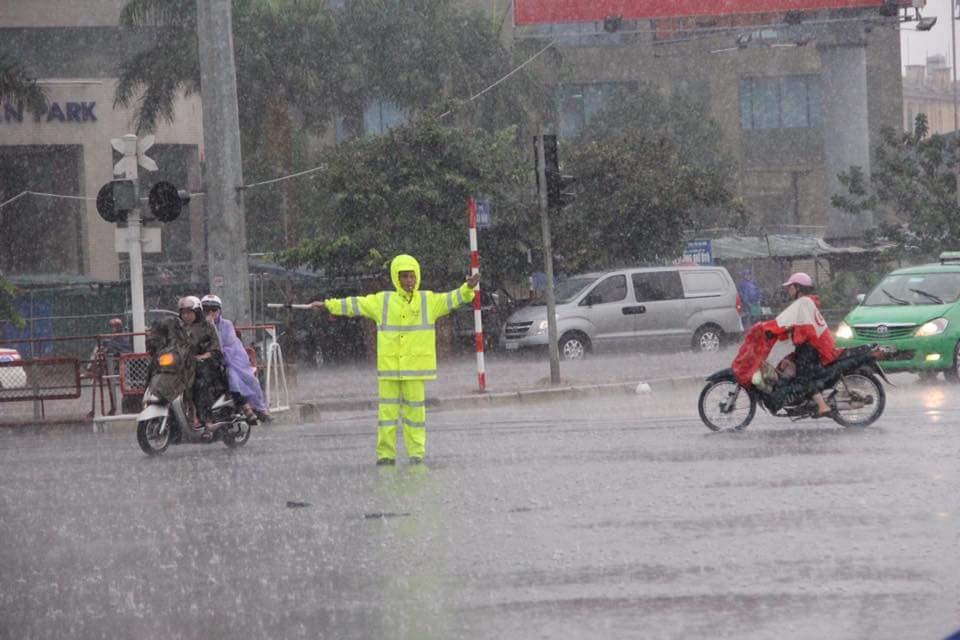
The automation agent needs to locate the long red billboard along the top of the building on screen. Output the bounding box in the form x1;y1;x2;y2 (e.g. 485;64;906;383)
513;0;883;25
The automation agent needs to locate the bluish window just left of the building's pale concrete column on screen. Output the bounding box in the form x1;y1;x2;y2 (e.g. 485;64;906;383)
740;76;823;130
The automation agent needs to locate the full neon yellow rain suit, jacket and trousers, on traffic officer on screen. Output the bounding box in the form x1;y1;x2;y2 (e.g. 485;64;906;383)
325;255;474;460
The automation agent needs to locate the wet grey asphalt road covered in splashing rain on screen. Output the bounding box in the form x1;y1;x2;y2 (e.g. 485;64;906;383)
0;386;960;639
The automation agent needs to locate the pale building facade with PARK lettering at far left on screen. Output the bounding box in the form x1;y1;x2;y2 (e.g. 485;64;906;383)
0;0;205;280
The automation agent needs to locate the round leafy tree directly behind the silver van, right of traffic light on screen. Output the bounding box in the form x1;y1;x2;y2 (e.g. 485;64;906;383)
553;85;745;271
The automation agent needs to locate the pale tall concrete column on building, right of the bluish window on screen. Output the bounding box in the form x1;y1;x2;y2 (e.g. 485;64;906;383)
817;41;874;239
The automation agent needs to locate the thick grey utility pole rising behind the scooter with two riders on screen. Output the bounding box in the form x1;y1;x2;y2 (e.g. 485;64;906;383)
197;0;250;324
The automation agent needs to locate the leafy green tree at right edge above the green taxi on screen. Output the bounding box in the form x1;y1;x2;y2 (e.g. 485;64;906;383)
832;114;960;256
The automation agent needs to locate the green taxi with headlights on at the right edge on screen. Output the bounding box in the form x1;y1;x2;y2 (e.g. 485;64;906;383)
834;251;960;381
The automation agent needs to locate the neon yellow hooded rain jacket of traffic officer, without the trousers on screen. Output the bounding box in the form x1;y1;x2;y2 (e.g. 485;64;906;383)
325;255;474;380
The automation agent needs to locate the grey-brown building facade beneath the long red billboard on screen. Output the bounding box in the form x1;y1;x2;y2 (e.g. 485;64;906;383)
472;0;903;240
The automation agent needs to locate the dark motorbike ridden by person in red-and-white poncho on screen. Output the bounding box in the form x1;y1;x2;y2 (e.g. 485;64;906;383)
698;345;889;431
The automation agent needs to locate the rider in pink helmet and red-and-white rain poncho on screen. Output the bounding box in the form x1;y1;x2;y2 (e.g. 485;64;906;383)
763;272;841;417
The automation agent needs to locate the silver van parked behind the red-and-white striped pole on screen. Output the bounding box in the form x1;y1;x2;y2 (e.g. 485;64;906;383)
502;266;743;360
